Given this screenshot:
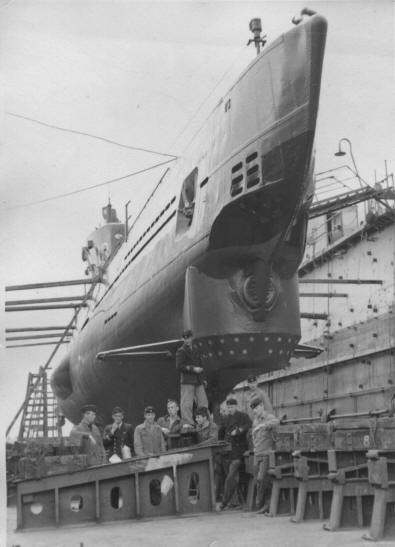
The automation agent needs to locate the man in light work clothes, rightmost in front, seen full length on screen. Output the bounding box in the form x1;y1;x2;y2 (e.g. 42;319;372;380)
250;397;280;513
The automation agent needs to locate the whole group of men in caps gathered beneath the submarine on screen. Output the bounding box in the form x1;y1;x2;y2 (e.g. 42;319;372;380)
70;331;279;513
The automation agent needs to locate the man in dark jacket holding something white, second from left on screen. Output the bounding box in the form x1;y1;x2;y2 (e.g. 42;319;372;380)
103;406;133;460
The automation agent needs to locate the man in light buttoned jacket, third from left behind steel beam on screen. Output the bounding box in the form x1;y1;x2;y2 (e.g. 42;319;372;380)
134;406;166;456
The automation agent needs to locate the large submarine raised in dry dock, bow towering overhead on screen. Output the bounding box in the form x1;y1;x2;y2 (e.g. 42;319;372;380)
51;10;327;424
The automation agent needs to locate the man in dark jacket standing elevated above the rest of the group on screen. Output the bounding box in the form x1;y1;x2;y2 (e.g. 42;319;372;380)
176;330;208;426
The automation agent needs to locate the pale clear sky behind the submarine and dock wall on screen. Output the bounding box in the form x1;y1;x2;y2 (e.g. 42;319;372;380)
0;0;395;440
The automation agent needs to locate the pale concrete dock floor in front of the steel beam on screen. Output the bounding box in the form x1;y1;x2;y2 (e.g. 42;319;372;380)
7;507;395;547
